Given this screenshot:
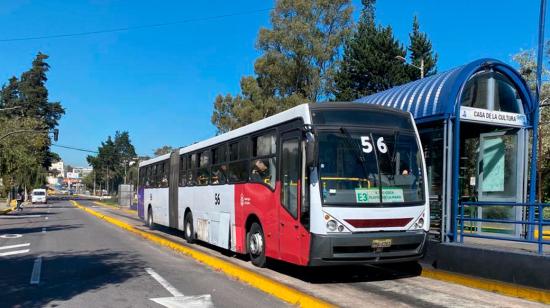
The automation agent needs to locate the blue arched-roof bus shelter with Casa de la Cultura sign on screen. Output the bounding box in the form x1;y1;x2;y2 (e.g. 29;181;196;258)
358;59;542;247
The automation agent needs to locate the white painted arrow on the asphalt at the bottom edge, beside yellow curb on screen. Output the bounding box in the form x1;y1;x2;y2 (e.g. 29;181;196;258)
145;267;214;308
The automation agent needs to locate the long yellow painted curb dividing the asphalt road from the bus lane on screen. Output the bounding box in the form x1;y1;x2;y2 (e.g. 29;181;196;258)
71;200;333;307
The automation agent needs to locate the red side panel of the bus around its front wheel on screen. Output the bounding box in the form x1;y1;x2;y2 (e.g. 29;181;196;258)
235;182;310;265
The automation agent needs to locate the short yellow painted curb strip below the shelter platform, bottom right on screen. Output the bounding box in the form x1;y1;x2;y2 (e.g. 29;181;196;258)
422;268;550;304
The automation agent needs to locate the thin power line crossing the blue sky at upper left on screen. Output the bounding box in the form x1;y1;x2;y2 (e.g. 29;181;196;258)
0;8;272;42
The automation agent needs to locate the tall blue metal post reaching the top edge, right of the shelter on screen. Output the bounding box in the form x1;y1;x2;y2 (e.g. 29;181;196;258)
528;0;546;240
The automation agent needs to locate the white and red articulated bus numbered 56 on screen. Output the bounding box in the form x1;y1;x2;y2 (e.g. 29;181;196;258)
138;103;430;267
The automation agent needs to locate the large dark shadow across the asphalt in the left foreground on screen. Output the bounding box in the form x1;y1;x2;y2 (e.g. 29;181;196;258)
0;250;144;307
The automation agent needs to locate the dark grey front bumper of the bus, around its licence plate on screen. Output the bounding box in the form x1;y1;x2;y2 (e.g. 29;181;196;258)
309;230;427;266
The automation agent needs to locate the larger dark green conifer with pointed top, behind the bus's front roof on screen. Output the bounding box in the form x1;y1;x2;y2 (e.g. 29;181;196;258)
334;0;411;101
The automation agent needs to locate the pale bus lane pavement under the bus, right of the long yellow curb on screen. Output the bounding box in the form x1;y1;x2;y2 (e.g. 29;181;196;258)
73;201;543;308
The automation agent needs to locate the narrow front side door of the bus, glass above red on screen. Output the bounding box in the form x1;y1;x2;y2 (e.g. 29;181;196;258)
279;130;302;264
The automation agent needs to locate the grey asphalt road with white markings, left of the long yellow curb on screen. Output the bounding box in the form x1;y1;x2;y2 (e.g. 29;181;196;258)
0;201;286;307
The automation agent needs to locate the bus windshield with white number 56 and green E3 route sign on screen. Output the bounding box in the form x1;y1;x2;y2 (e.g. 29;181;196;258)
318;127;425;206
